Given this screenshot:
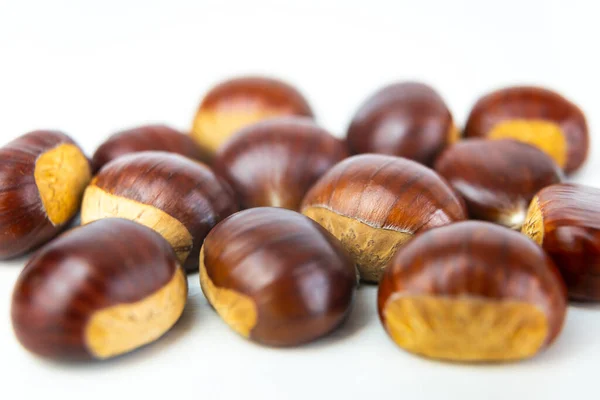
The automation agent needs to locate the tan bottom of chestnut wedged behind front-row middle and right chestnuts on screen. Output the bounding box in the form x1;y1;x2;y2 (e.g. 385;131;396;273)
302;206;413;282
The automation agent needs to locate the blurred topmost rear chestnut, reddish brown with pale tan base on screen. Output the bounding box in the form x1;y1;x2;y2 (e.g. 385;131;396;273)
191;76;313;154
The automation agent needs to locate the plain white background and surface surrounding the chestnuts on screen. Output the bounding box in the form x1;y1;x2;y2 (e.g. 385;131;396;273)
0;0;600;400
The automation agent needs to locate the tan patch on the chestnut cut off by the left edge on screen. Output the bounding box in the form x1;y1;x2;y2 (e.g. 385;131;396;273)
33;143;92;226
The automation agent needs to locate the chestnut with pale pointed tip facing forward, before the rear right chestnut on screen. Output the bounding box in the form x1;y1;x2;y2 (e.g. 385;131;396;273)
435;139;562;229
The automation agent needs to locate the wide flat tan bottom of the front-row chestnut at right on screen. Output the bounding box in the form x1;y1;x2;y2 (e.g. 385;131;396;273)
384;295;548;362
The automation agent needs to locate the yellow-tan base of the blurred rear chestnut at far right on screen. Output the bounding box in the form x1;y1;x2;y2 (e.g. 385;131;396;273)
488;119;567;168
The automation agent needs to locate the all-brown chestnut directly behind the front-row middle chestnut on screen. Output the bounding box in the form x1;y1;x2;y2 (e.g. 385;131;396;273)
213;117;348;210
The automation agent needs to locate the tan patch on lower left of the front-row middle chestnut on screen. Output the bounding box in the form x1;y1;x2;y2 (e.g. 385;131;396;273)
200;246;258;338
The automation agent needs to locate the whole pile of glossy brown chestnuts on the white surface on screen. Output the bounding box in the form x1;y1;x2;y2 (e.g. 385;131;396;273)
0;77;600;362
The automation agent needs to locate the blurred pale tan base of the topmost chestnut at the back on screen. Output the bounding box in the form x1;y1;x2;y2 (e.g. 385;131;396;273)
191;107;287;153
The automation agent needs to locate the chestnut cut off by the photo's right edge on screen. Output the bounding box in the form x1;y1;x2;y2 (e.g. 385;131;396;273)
522;183;600;301
